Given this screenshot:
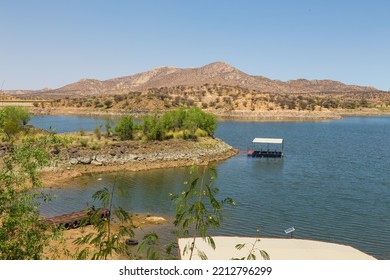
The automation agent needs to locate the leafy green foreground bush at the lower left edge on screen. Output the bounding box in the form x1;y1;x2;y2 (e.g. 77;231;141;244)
0;138;53;260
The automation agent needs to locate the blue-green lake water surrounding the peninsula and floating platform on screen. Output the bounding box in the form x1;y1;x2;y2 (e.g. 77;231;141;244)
31;116;390;259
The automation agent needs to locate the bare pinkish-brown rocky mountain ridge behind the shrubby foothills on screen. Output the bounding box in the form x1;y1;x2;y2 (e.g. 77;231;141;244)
5;62;379;98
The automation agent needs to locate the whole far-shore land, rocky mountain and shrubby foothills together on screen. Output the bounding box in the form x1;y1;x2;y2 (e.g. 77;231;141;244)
0;62;390;120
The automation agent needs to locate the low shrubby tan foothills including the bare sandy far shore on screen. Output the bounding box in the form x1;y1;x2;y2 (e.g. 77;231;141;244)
17;85;390;120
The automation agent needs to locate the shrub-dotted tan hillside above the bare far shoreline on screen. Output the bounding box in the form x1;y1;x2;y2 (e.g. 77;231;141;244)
25;84;390;118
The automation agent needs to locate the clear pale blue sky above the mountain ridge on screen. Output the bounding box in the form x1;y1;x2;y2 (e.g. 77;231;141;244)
0;0;390;90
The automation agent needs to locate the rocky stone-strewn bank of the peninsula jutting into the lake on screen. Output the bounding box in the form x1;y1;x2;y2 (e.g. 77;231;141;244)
41;137;238;187
